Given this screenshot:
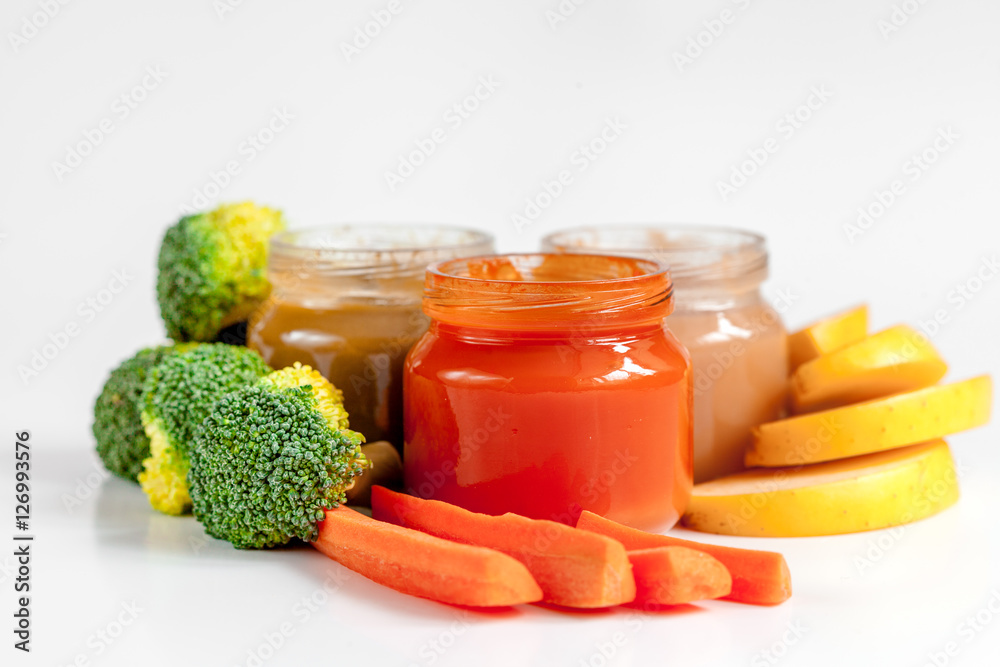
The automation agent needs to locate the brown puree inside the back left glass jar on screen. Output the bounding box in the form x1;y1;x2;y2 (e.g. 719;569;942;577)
247;299;428;450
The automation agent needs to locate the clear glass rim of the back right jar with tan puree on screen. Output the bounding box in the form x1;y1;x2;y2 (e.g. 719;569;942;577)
542;223;768;287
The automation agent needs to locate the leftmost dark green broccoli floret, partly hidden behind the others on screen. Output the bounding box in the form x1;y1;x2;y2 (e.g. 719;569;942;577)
93;345;190;483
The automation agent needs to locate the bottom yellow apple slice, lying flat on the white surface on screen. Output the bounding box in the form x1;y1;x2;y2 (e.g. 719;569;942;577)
681;440;958;537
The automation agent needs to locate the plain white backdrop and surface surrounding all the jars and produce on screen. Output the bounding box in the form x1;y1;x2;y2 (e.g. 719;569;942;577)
0;0;1000;666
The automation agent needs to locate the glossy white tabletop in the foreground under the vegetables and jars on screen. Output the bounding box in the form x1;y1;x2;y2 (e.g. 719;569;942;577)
11;444;1000;667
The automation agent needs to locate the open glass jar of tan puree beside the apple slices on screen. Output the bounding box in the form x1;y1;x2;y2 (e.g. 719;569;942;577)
542;225;788;483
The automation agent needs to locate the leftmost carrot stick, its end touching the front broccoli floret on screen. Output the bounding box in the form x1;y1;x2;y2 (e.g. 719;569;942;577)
313;506;542;607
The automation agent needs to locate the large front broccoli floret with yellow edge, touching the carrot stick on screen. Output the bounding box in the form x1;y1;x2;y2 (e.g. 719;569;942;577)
188;364;369;549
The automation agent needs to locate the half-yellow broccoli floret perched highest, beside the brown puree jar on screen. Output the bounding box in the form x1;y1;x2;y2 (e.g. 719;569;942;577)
156;202;285;342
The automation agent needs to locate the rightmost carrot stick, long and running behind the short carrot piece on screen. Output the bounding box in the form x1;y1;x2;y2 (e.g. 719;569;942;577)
576;510;792;605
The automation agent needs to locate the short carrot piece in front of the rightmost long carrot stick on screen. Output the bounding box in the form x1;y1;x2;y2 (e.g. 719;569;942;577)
628;547;733;606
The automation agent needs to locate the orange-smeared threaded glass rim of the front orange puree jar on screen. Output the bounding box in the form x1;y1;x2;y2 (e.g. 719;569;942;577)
424;253;673;330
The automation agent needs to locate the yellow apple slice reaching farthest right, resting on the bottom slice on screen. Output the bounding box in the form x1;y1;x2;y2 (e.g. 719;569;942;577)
744;375;993;468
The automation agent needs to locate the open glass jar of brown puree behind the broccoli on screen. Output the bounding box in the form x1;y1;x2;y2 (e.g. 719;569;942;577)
247;224;494;451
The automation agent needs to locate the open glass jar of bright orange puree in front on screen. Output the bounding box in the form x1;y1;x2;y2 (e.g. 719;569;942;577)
403;255;691;528
